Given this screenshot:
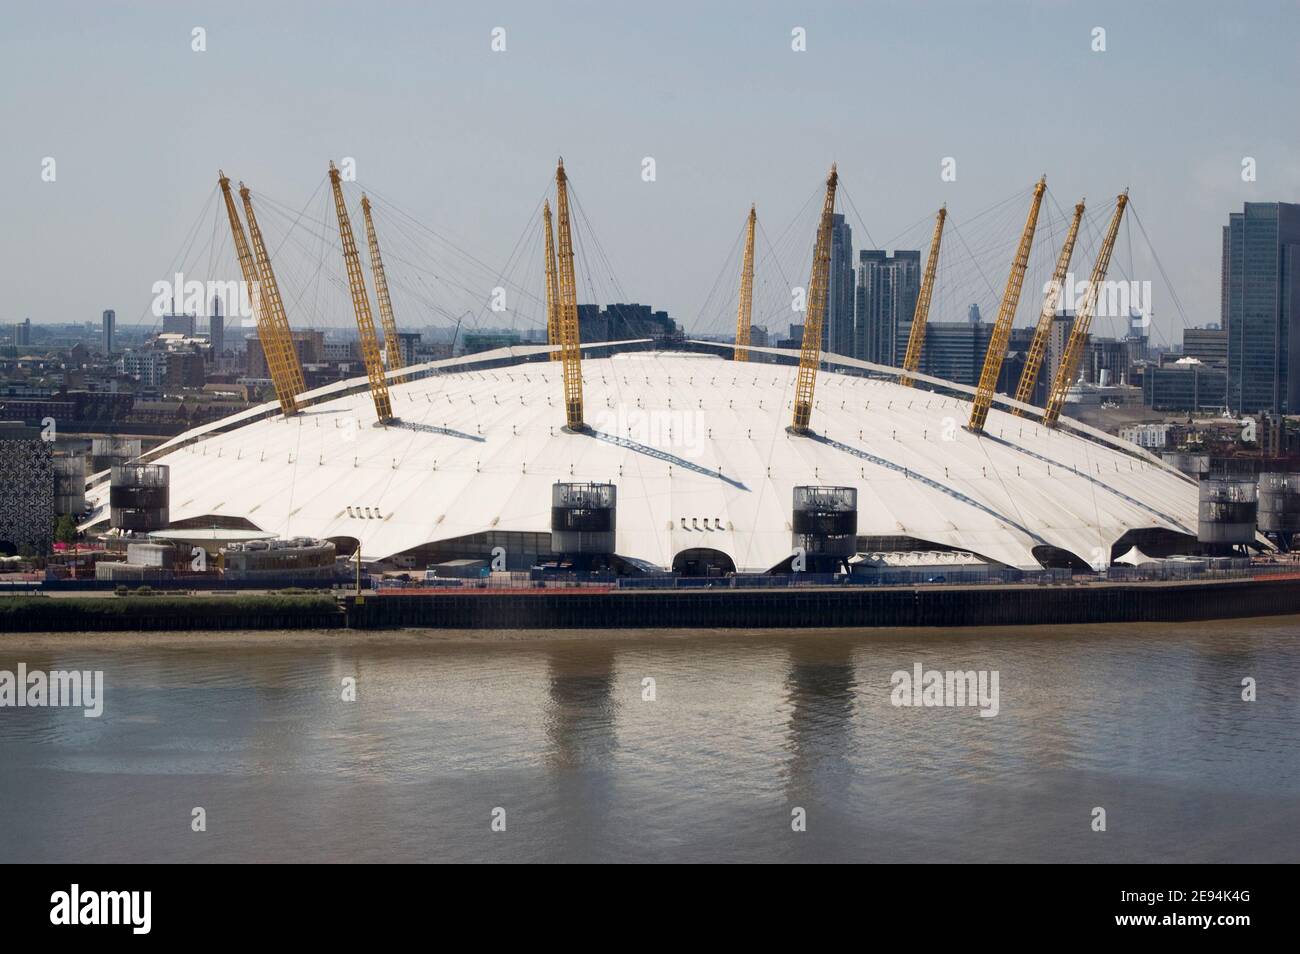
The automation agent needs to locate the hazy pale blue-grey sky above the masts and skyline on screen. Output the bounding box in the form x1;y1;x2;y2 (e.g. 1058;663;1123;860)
0;0;1300;348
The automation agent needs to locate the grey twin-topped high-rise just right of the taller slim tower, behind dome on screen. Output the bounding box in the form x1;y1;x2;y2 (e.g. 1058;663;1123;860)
853;248;920;367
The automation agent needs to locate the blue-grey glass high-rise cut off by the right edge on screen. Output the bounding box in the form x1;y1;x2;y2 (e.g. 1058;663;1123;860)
1219;201;1300;413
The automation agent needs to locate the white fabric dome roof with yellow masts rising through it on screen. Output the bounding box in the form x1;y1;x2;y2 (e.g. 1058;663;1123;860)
87;348;1196;571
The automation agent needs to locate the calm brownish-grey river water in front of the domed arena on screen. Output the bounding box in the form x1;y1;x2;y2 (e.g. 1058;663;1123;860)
0;617;1300;862
